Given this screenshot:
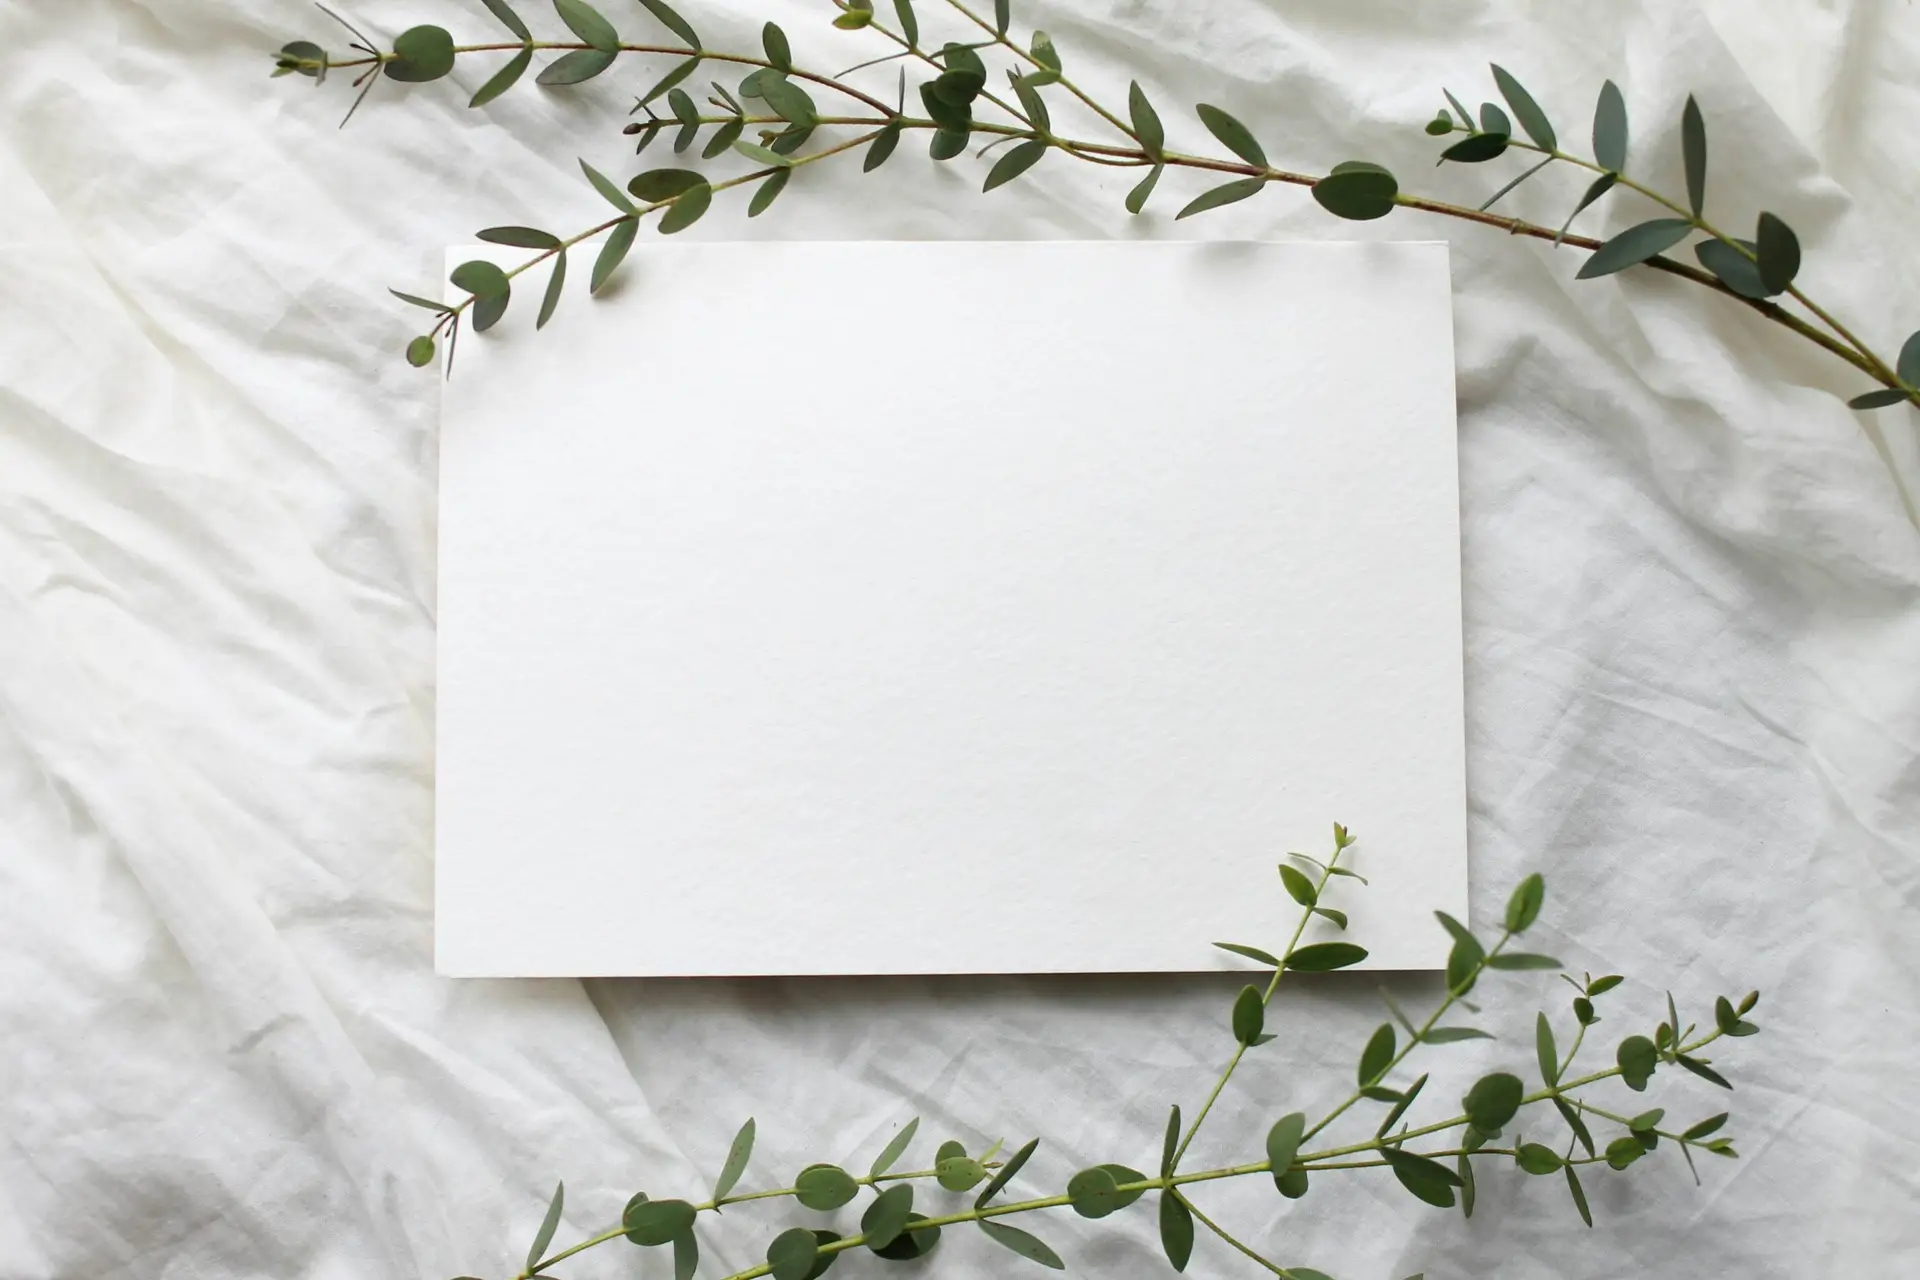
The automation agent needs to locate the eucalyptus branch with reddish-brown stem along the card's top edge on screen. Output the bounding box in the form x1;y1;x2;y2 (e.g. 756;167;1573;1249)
275;0;1920;520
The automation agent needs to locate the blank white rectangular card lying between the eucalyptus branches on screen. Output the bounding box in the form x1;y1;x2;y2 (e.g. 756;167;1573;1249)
436;238;1467;975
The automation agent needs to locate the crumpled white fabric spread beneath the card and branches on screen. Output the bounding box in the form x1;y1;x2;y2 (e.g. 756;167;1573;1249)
0;0;1920;1280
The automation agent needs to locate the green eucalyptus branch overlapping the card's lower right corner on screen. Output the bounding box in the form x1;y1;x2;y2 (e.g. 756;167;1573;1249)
441;825;1759;1280
